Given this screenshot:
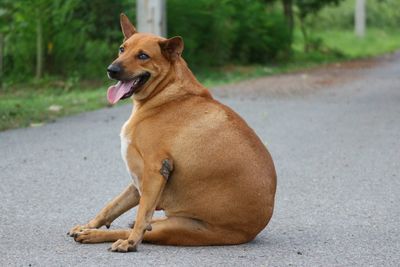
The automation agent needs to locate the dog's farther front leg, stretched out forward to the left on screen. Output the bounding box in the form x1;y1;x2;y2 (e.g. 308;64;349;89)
68;184;140;238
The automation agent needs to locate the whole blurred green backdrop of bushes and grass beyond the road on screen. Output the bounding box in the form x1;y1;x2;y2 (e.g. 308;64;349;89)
0;0;400;130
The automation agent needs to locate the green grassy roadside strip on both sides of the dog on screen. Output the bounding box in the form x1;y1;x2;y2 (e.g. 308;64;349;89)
0;29;400;130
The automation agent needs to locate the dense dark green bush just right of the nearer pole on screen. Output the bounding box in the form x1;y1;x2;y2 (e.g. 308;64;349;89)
167;0;291;69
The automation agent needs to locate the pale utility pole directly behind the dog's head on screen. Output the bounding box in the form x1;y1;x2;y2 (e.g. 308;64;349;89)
136;0;167;37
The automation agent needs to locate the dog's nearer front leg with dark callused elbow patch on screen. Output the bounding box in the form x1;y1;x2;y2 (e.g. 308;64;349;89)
110;159;173;252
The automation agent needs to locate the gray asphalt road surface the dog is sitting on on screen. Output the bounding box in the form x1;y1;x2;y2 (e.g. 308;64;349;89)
0;53;400;266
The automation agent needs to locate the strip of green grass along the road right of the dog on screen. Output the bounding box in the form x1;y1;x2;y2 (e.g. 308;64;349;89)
200;29;400;87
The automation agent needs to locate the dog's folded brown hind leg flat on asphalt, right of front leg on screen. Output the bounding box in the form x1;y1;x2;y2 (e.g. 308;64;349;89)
143;217;250;246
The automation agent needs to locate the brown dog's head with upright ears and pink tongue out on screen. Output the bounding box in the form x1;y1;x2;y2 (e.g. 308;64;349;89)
107;14;183;104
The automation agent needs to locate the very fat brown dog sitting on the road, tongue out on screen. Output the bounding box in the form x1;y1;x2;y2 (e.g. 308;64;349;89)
69;14;276;252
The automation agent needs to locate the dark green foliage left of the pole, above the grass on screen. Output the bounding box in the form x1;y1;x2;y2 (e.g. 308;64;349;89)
0;0;135;82
